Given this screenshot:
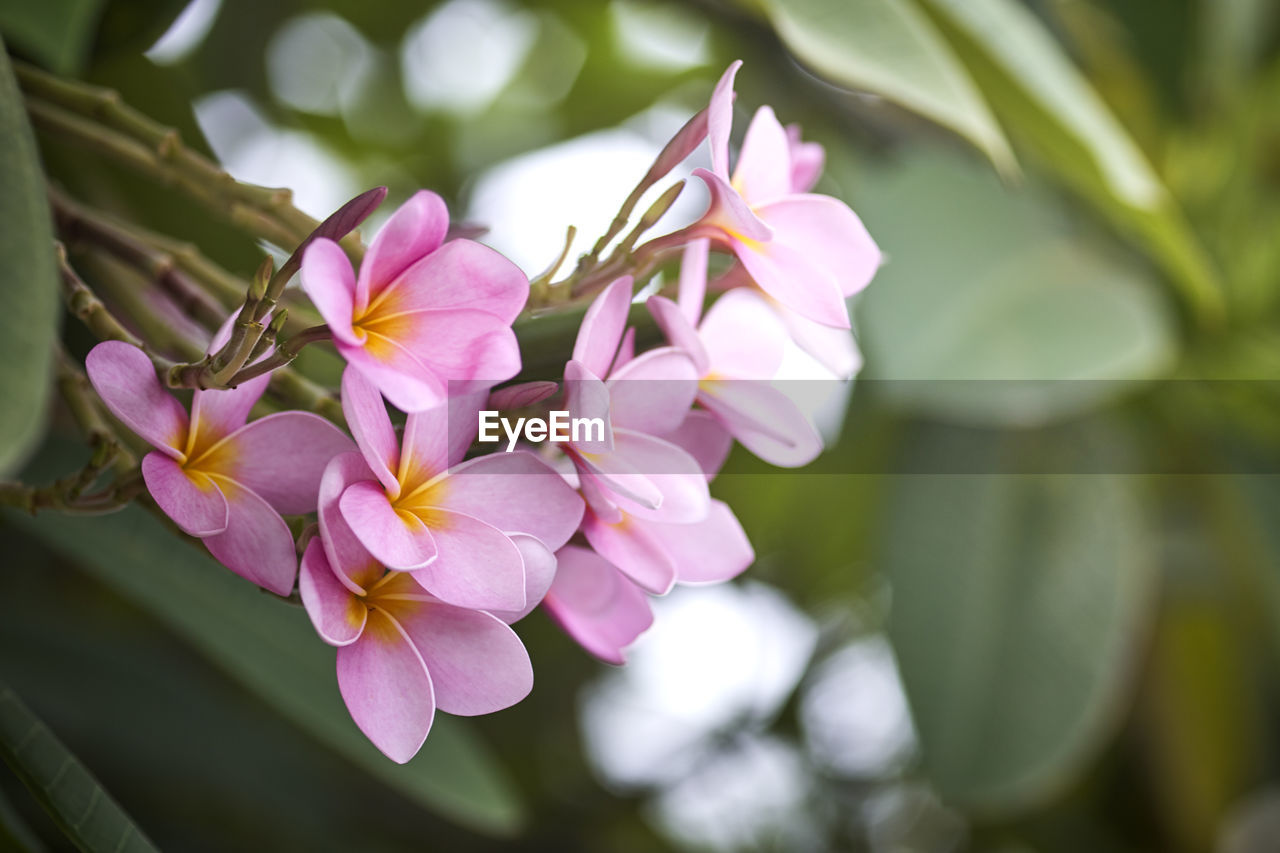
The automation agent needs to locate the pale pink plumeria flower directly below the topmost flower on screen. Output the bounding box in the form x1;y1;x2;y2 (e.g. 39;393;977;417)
648;243;819;467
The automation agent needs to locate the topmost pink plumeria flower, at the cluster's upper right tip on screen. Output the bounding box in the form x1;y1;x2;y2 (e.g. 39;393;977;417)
694;61;881;329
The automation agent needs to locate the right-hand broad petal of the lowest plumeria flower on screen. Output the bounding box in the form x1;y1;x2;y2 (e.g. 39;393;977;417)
384;601;534;717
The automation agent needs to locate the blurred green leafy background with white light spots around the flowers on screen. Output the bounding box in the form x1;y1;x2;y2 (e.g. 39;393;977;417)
0;0;1280;853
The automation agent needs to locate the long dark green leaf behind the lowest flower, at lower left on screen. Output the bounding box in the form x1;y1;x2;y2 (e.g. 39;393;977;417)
12;507;525;835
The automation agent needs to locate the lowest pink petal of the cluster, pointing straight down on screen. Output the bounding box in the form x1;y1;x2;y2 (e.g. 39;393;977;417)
338;610;435;765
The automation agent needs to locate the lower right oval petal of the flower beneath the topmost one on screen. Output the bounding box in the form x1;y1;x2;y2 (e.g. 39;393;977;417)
698;379;822;467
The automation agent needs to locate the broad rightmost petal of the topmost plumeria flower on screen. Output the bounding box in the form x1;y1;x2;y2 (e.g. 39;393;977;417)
756;195;881;298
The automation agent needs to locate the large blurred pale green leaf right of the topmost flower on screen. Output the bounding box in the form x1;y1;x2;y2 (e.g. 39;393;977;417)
856;156;1174;425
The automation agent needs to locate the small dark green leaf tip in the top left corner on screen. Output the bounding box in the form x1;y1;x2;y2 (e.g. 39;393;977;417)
0;0;104;74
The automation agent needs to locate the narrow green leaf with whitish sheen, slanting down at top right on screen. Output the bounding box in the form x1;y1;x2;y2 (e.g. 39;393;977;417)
922;0;1224;323
